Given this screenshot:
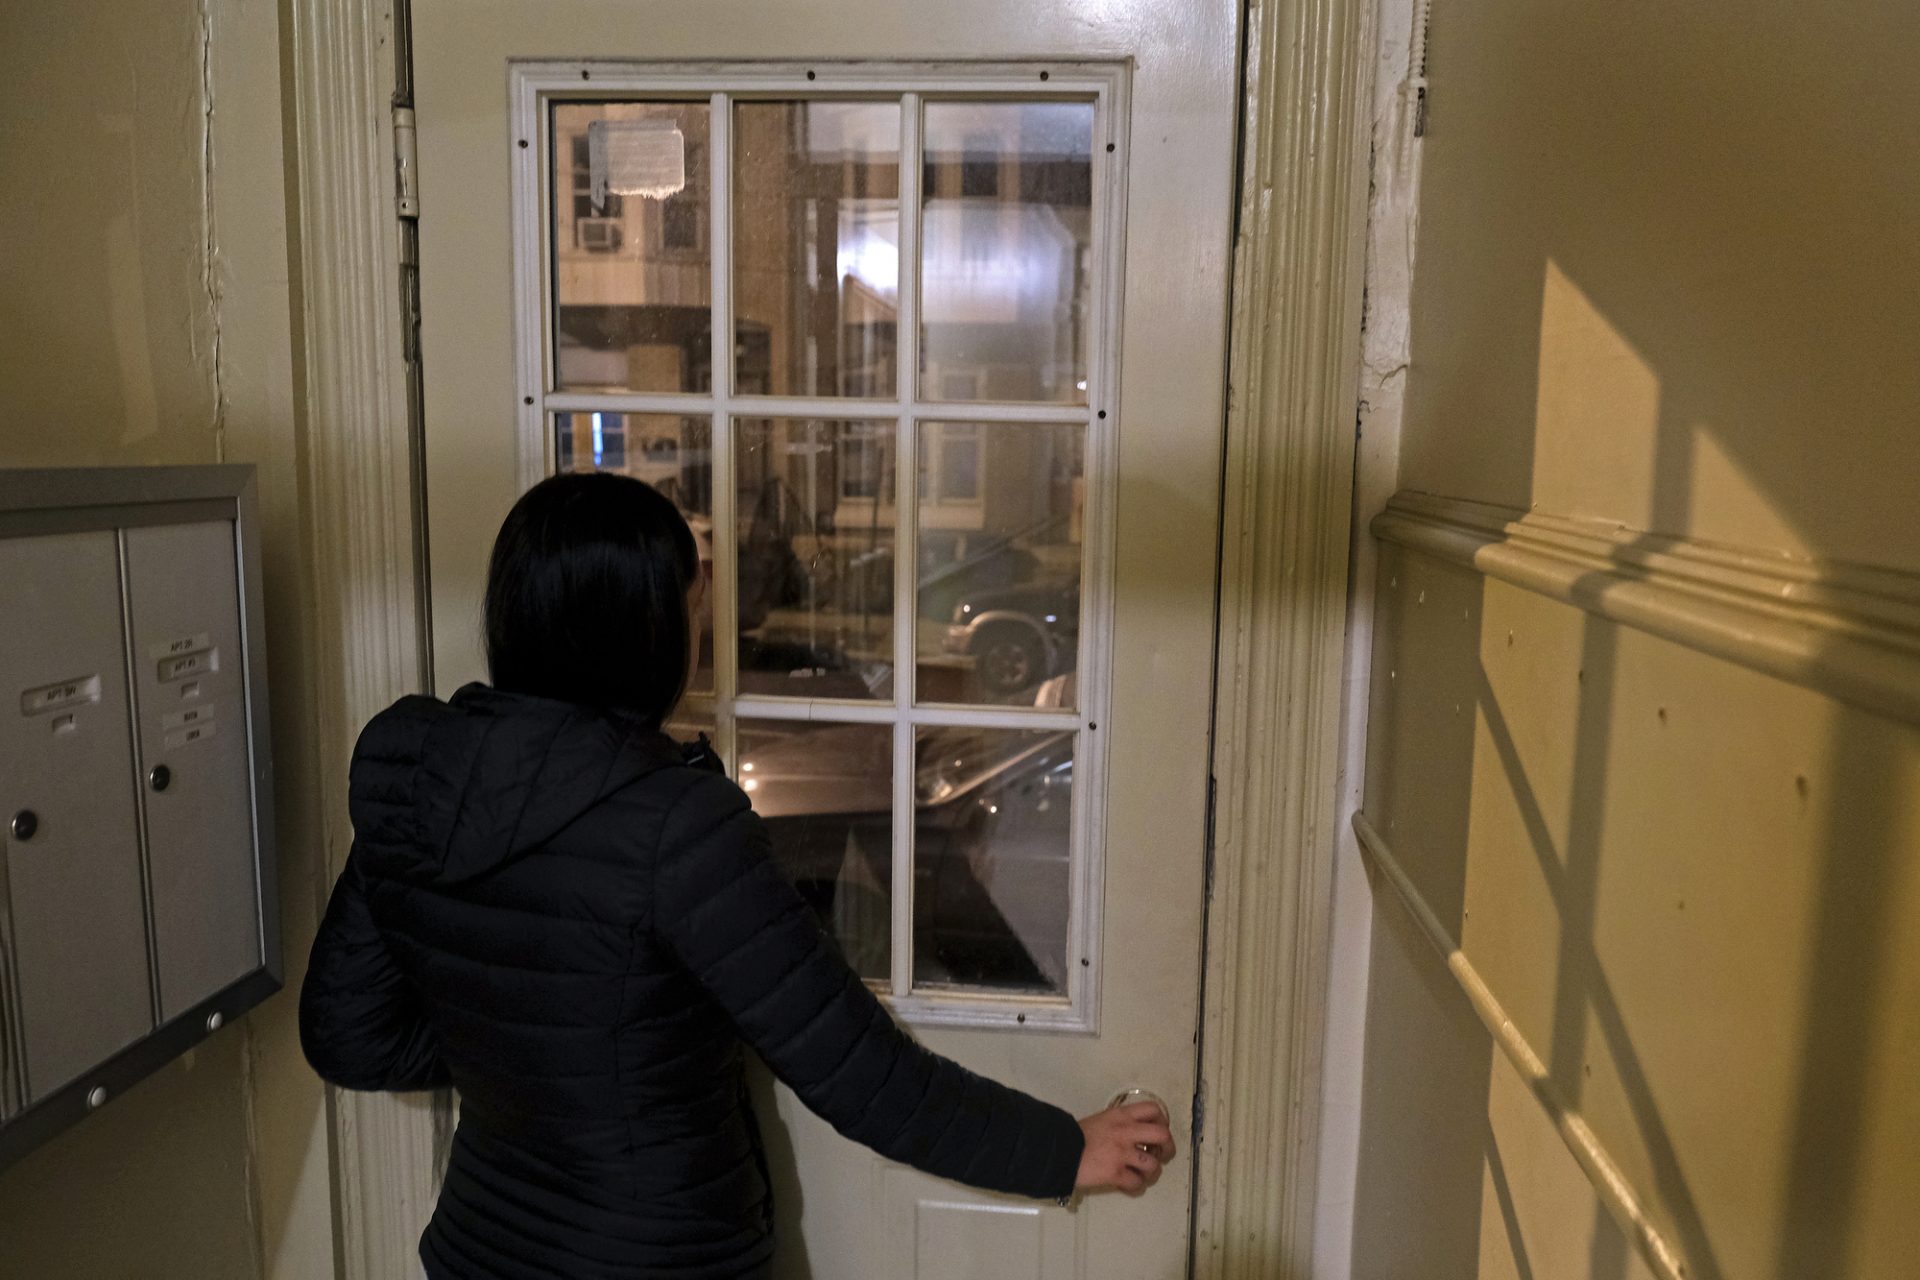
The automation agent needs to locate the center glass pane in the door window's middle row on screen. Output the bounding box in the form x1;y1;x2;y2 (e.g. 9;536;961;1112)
735;418;897;700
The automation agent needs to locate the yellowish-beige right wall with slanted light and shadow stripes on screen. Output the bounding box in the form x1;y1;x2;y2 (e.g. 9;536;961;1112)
1352;0;1920;1280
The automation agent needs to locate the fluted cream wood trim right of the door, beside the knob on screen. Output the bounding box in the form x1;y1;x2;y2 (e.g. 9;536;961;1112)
1194;0;1375;1280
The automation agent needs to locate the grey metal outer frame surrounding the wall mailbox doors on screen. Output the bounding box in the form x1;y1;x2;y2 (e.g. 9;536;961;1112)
0;464;284;1171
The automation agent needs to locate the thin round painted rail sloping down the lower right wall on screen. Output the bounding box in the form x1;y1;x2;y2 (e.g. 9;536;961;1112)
1354;814;1686;1280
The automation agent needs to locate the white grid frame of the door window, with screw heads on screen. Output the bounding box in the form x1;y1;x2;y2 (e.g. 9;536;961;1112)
507;61;1129;1034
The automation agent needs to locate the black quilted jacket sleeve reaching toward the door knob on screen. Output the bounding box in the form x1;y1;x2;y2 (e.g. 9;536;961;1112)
655;777;1085;1197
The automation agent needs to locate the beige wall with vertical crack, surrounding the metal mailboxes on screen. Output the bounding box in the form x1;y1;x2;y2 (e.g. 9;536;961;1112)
0;0;332;1280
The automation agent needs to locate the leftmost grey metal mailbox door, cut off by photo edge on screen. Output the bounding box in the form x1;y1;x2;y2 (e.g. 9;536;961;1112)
0;532;154;1103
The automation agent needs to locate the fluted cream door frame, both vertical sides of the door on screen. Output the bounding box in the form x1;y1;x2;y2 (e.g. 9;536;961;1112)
286;0;1375;1280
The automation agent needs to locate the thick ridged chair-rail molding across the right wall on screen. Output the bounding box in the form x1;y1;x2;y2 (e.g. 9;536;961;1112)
1373;493;1920;723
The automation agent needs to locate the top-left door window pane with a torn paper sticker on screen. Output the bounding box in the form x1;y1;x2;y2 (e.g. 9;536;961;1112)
551;102;712;391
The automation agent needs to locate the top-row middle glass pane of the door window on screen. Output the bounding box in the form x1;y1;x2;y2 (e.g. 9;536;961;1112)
733;102;900;399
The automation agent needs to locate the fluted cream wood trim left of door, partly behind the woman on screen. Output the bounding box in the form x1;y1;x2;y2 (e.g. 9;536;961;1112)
290;0;445;1280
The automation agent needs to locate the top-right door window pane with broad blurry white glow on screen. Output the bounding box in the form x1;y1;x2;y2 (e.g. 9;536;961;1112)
920;102;1092;403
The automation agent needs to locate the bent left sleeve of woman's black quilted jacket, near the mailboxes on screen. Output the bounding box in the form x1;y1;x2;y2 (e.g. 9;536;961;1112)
300;850;449;1090
